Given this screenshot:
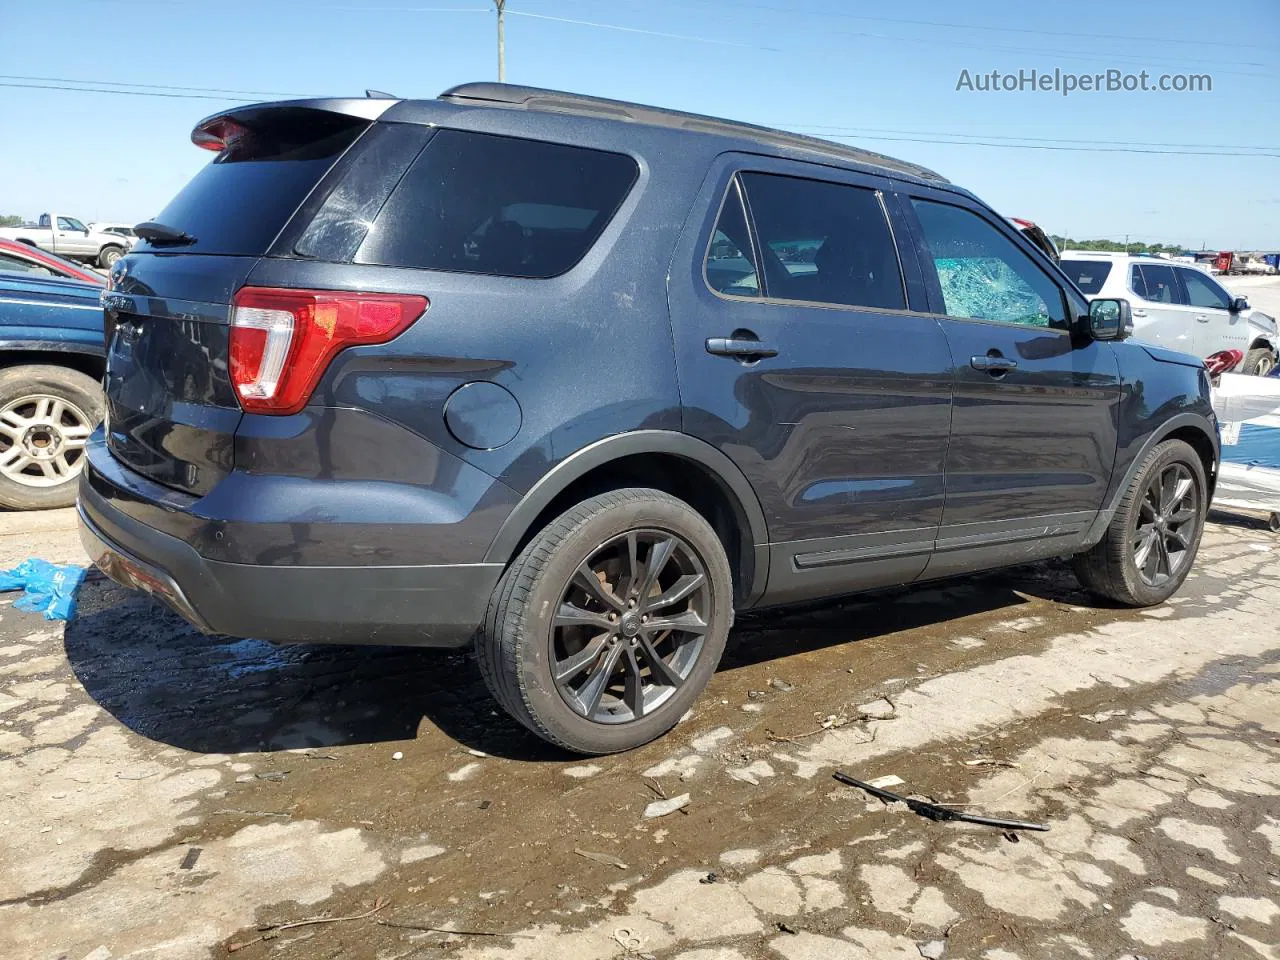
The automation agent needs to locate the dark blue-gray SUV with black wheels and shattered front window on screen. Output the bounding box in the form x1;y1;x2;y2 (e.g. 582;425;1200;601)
79;83;1217;754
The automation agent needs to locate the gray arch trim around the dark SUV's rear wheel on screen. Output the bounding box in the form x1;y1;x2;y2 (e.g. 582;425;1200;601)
484;430;768;607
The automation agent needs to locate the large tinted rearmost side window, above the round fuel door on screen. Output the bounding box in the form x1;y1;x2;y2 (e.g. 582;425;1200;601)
356;131;639;278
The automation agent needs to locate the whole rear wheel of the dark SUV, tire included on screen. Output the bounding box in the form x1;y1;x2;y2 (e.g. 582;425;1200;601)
475;488;733;755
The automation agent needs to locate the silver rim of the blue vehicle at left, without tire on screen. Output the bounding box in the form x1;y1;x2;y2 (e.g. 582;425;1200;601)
0;394;93;486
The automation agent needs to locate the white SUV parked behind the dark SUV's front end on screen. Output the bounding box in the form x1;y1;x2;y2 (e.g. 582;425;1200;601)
1062;250;1280;376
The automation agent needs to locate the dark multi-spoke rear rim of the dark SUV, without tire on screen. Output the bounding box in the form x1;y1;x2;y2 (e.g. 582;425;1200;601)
550;530;713;723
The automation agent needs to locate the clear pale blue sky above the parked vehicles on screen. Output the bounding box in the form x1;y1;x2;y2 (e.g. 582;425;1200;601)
0;0;1280;250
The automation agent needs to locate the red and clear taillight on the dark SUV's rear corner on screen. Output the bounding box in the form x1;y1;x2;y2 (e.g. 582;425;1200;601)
230;287;430;413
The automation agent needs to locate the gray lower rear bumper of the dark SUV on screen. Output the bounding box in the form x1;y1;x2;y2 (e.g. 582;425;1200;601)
77;450;502;646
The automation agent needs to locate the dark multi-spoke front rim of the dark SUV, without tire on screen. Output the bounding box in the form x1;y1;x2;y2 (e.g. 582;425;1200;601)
1132;463;1199;586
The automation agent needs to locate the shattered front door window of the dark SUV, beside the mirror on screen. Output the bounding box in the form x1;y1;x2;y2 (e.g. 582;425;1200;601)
911;200;1066;330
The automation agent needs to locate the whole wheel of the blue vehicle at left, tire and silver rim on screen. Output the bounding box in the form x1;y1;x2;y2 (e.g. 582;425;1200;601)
0;364;102;509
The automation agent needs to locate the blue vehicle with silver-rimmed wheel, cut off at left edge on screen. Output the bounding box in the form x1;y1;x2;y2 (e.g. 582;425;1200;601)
0;261;105;509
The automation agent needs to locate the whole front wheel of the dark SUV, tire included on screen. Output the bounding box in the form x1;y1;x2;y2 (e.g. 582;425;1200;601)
1074;440;1208;607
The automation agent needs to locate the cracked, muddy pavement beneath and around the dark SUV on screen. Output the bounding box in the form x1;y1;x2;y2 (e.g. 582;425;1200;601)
0;511;1280;960
